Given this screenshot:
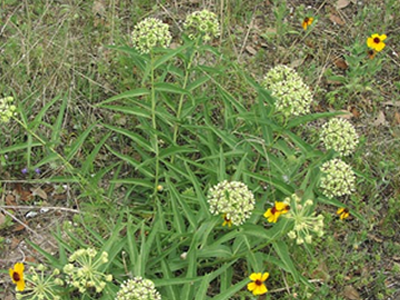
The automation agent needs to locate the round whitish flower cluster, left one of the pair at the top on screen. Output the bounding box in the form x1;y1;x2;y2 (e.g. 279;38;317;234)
132;18;172;53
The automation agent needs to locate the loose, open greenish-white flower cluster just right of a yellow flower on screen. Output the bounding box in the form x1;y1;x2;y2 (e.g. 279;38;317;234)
283;194;324;245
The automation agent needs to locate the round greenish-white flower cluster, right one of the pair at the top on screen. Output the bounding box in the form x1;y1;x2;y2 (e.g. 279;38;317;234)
183;10;220;42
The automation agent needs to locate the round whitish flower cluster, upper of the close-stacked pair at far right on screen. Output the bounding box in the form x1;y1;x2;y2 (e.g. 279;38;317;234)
320;118;358;156
